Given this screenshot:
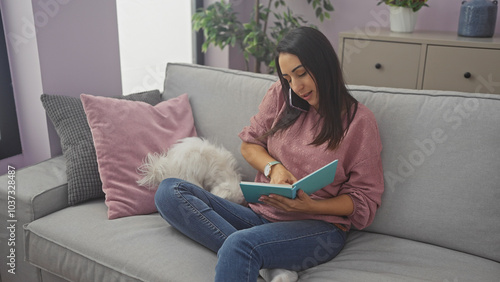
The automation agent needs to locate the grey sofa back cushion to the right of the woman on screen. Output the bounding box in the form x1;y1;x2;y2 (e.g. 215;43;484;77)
350;86;500;261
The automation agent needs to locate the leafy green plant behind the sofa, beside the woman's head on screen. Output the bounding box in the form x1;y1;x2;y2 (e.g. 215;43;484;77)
192;0;333;72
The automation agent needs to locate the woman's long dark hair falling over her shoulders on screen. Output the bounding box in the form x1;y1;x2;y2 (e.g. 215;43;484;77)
264;27;358;150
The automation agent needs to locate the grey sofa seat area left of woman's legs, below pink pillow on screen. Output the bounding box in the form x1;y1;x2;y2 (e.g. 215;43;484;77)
25;200;217;281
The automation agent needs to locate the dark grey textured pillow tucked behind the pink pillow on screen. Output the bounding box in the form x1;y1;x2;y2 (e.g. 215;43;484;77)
41;90;162;206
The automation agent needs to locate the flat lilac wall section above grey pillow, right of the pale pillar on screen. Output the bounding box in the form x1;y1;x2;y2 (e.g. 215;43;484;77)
33;0;122;156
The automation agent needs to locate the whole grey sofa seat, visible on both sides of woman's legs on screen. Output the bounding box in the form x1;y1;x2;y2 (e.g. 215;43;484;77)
25;200;500;282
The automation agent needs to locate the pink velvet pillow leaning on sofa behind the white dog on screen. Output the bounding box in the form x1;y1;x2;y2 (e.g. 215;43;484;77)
80;94;196;219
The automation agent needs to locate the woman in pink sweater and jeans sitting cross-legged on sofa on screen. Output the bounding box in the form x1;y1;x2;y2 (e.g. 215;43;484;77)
155;27;384;281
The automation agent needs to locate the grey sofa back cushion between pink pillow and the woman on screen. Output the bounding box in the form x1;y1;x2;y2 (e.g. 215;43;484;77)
163;63;278;181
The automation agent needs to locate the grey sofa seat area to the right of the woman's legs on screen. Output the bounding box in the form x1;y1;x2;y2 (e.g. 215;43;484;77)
300;231;500;282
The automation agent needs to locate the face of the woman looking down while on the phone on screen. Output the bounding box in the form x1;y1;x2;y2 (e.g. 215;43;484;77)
278;53;319;110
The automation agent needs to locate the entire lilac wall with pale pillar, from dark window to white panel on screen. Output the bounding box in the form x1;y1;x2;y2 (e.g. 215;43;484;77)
0;0;122;175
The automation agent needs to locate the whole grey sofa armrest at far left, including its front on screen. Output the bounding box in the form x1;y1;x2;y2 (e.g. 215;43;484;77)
0;156;68;281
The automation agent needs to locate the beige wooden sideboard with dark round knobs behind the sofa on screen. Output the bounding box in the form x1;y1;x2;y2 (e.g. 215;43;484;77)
339;30;500;94
